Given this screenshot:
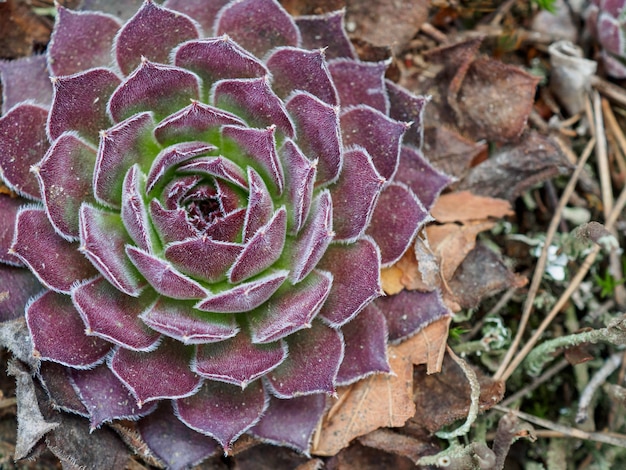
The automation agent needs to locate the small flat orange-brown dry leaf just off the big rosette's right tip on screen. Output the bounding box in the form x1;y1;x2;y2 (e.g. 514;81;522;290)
431;191;513;223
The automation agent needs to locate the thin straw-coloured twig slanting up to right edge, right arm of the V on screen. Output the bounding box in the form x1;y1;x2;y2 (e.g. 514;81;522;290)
497;182;626;381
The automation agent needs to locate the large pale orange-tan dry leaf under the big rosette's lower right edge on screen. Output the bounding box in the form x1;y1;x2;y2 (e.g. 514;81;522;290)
312;317;450;455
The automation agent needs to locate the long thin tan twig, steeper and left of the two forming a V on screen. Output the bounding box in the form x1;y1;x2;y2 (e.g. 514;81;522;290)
494;138;595;380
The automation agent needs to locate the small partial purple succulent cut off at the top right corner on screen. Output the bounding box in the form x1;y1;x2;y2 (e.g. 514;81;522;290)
586;0;626;78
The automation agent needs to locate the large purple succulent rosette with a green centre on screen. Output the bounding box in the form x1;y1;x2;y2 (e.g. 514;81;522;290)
0;0;449;465
